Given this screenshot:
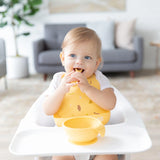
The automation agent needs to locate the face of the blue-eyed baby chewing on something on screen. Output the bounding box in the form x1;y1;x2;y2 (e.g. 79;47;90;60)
62;41;100;78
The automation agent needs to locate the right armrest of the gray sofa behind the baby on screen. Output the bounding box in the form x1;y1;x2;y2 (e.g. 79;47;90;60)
133;36;144;70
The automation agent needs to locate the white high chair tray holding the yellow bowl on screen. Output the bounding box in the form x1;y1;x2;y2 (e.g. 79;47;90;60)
10;122;151;156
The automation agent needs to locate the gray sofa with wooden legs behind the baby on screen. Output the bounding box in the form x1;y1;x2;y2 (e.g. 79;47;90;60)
33;24;143;80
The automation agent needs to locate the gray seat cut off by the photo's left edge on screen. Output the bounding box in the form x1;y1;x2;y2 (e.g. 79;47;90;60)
0;39;7;89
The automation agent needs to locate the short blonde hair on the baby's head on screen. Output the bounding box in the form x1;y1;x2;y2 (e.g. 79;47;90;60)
61;27;102;58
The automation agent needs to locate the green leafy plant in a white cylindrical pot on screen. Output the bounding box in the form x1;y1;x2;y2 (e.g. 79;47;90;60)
0;0;42;78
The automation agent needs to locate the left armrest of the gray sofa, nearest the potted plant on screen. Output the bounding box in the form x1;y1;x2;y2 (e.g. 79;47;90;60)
33;39;45;68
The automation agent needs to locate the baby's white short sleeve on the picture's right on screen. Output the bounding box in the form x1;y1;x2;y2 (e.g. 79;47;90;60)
95;70;112;90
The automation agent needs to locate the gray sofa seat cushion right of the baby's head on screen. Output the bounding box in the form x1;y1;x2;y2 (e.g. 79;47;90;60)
102;49;136;63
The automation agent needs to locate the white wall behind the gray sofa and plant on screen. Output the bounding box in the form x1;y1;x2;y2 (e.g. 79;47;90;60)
0;0;160;73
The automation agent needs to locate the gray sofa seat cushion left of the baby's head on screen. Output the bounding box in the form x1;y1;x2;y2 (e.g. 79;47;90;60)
38;50;61;65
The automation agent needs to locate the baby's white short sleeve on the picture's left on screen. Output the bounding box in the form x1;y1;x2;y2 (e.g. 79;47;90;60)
45;72;64;96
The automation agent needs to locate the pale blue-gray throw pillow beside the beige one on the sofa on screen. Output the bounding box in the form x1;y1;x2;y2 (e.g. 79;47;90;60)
86;20;115;50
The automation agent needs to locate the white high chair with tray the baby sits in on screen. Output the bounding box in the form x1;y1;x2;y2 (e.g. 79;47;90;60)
9;87;152;160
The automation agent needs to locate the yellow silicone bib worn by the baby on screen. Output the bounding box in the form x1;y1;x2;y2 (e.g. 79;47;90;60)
54;75;110;127
